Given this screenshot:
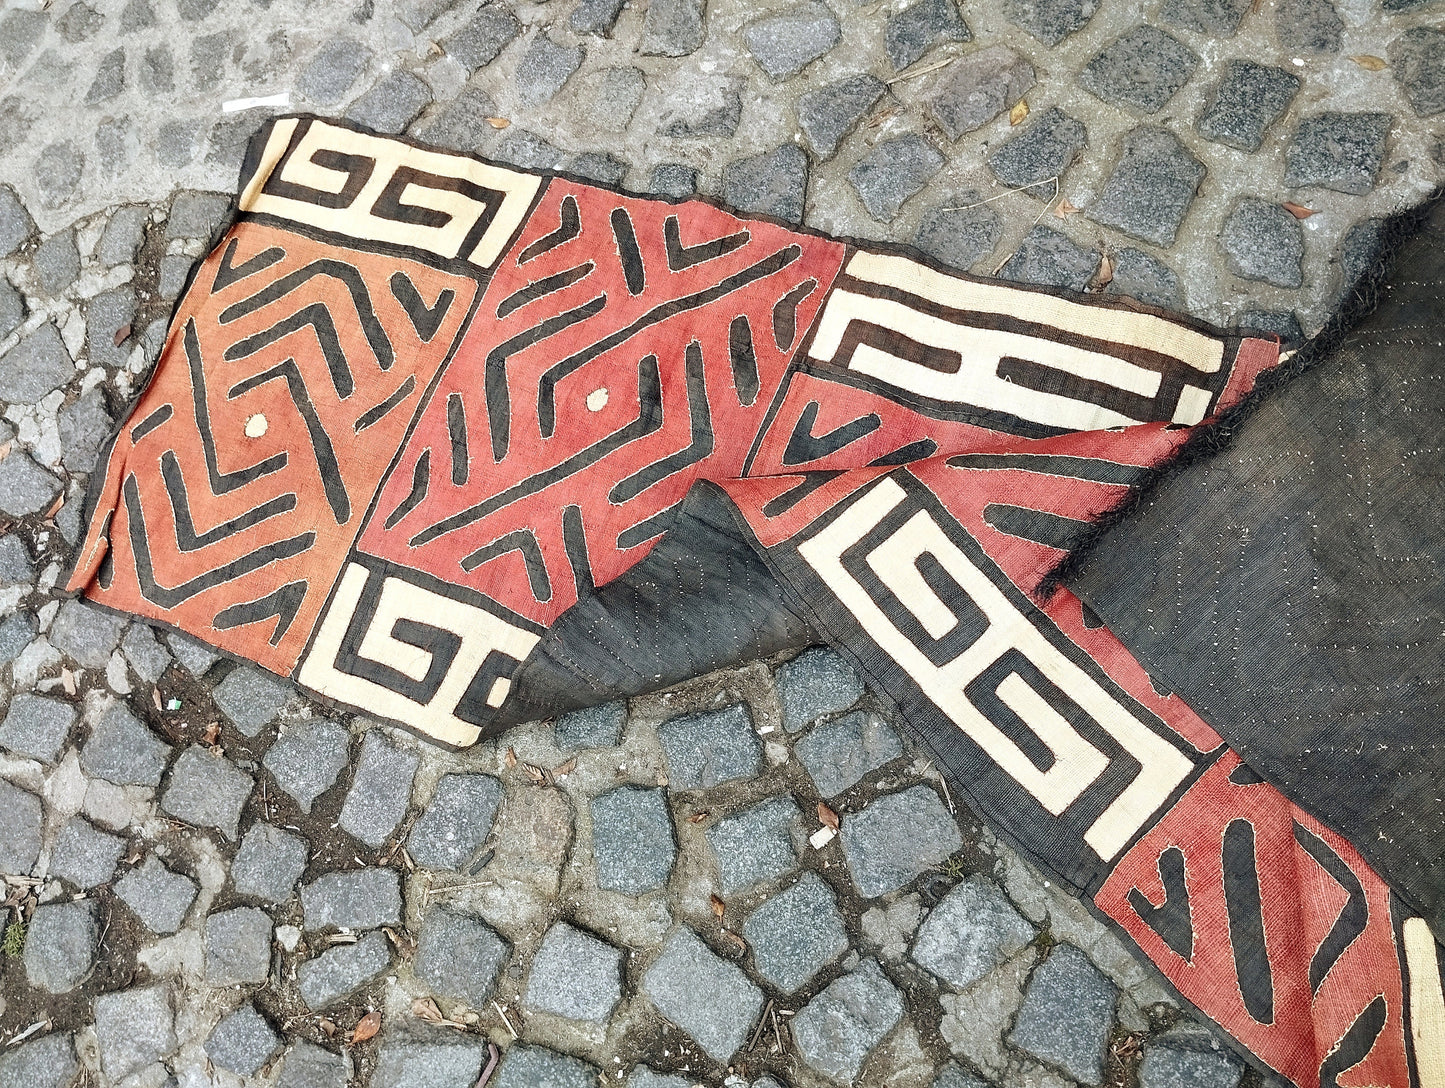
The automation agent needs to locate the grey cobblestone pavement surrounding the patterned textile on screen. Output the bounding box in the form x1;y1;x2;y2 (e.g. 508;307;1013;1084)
0;0;1445;1088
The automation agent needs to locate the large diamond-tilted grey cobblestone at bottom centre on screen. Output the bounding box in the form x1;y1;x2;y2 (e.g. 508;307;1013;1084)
642;926;763;1062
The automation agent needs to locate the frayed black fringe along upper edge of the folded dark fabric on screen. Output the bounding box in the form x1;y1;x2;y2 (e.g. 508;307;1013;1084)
1036;188;1445;601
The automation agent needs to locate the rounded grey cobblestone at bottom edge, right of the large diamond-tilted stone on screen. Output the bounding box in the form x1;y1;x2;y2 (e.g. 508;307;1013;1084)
790;959;903;1084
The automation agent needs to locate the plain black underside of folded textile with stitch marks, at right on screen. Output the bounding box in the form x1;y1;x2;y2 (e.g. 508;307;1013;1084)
1065;195;1445;935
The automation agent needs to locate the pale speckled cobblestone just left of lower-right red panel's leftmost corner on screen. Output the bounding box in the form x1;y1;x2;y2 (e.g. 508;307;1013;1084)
913;880;1035;990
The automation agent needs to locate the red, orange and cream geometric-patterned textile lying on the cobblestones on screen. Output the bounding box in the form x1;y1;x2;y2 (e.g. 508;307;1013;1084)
69;117;1445;1088
